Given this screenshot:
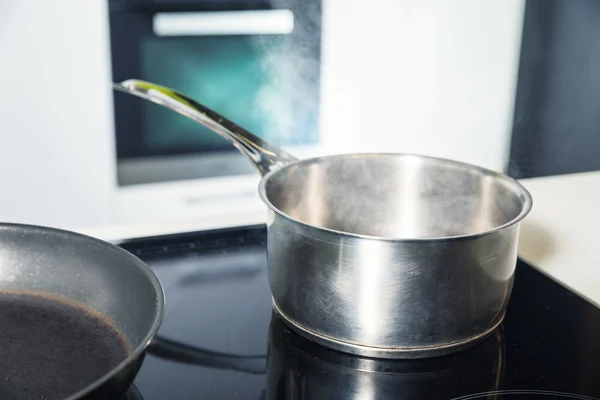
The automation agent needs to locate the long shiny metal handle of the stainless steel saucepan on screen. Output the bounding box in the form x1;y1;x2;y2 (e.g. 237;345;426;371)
113;79;297;176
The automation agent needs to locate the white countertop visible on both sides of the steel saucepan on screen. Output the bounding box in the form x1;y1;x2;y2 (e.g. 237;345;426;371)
80;172;600;306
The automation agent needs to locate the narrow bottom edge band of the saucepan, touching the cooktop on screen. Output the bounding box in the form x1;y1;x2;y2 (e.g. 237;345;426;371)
272;299;504;359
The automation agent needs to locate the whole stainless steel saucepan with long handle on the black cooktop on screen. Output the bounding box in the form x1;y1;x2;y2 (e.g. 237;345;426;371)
114;80;532;358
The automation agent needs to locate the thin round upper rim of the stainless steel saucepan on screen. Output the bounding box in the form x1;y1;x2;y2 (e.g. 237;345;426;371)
258;153;533;243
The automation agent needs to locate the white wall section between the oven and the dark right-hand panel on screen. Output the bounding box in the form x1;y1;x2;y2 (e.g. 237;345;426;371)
322;0;524;170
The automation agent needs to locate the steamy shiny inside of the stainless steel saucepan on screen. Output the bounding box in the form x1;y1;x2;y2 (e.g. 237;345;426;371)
266;155;526;238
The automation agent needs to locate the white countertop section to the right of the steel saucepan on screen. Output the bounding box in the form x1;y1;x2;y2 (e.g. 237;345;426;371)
519;172;600;307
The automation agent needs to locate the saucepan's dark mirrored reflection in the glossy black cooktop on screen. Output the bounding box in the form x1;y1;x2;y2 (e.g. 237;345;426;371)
266;314;504;400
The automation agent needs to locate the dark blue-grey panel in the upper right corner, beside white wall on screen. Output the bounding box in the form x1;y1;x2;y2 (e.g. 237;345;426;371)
508;0;600;178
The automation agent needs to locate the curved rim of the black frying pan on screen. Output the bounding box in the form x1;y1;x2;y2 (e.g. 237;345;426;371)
0;222;165;400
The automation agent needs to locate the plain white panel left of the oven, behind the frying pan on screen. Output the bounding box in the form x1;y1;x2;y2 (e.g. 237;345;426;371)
0;0;115;228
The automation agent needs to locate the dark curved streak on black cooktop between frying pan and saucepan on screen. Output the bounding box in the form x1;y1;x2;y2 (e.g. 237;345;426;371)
147;336;267;375
